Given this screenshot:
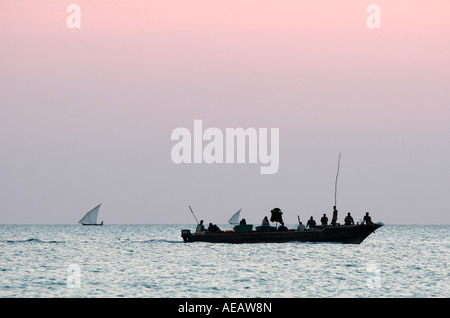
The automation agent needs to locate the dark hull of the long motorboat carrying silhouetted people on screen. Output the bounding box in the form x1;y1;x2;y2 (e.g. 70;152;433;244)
181;224;381;244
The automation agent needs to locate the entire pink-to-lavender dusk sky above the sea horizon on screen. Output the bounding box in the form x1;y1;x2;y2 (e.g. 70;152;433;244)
0;0;450;224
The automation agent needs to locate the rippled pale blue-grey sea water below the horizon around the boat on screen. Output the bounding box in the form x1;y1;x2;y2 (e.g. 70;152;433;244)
0;224;450;298
